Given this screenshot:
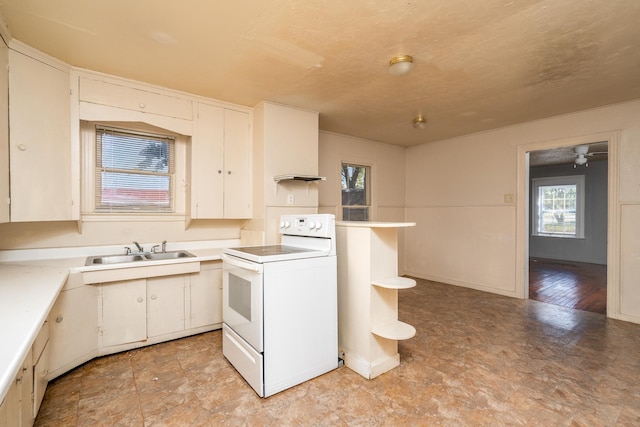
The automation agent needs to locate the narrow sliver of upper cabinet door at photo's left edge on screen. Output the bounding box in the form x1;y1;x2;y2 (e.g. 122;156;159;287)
0;38;9;223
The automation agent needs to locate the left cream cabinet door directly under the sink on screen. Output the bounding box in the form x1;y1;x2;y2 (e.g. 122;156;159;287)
100;279;147;347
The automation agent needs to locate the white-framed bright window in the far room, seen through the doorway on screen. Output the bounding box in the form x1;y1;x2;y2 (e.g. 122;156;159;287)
532;175;584;238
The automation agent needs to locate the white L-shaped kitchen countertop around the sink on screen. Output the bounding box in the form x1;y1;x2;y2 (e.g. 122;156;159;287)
0;246;229;403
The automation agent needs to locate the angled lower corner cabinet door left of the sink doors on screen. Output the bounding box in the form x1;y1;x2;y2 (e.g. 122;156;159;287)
48;285;98;380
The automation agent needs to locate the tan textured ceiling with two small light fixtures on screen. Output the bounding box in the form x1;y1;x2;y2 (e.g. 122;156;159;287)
0;0;640;146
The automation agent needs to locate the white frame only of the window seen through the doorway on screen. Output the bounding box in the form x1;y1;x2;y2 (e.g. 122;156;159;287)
531;175;585;239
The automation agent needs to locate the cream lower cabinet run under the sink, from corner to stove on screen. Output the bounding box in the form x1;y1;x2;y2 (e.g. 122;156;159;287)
44;261;222;384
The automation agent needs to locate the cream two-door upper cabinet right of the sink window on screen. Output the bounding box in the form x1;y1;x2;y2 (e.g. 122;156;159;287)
191;103;252;219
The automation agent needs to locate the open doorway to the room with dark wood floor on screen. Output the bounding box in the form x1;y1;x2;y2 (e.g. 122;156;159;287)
524;141;609;314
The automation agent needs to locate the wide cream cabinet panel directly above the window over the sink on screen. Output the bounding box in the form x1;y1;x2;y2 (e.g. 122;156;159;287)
79;77;193;120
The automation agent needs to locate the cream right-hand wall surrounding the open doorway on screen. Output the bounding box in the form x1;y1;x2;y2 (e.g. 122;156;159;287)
406;100;640;323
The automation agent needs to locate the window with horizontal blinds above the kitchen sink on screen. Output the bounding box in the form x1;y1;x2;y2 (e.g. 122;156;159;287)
95;126;175;212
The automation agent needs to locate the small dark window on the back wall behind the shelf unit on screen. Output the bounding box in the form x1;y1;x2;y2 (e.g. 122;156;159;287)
341;163;371;221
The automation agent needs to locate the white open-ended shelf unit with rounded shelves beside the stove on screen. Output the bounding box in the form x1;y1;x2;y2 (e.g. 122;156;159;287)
336;221;416;379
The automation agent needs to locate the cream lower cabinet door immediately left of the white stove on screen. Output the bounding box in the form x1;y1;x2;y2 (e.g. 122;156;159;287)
189;262;222;328
